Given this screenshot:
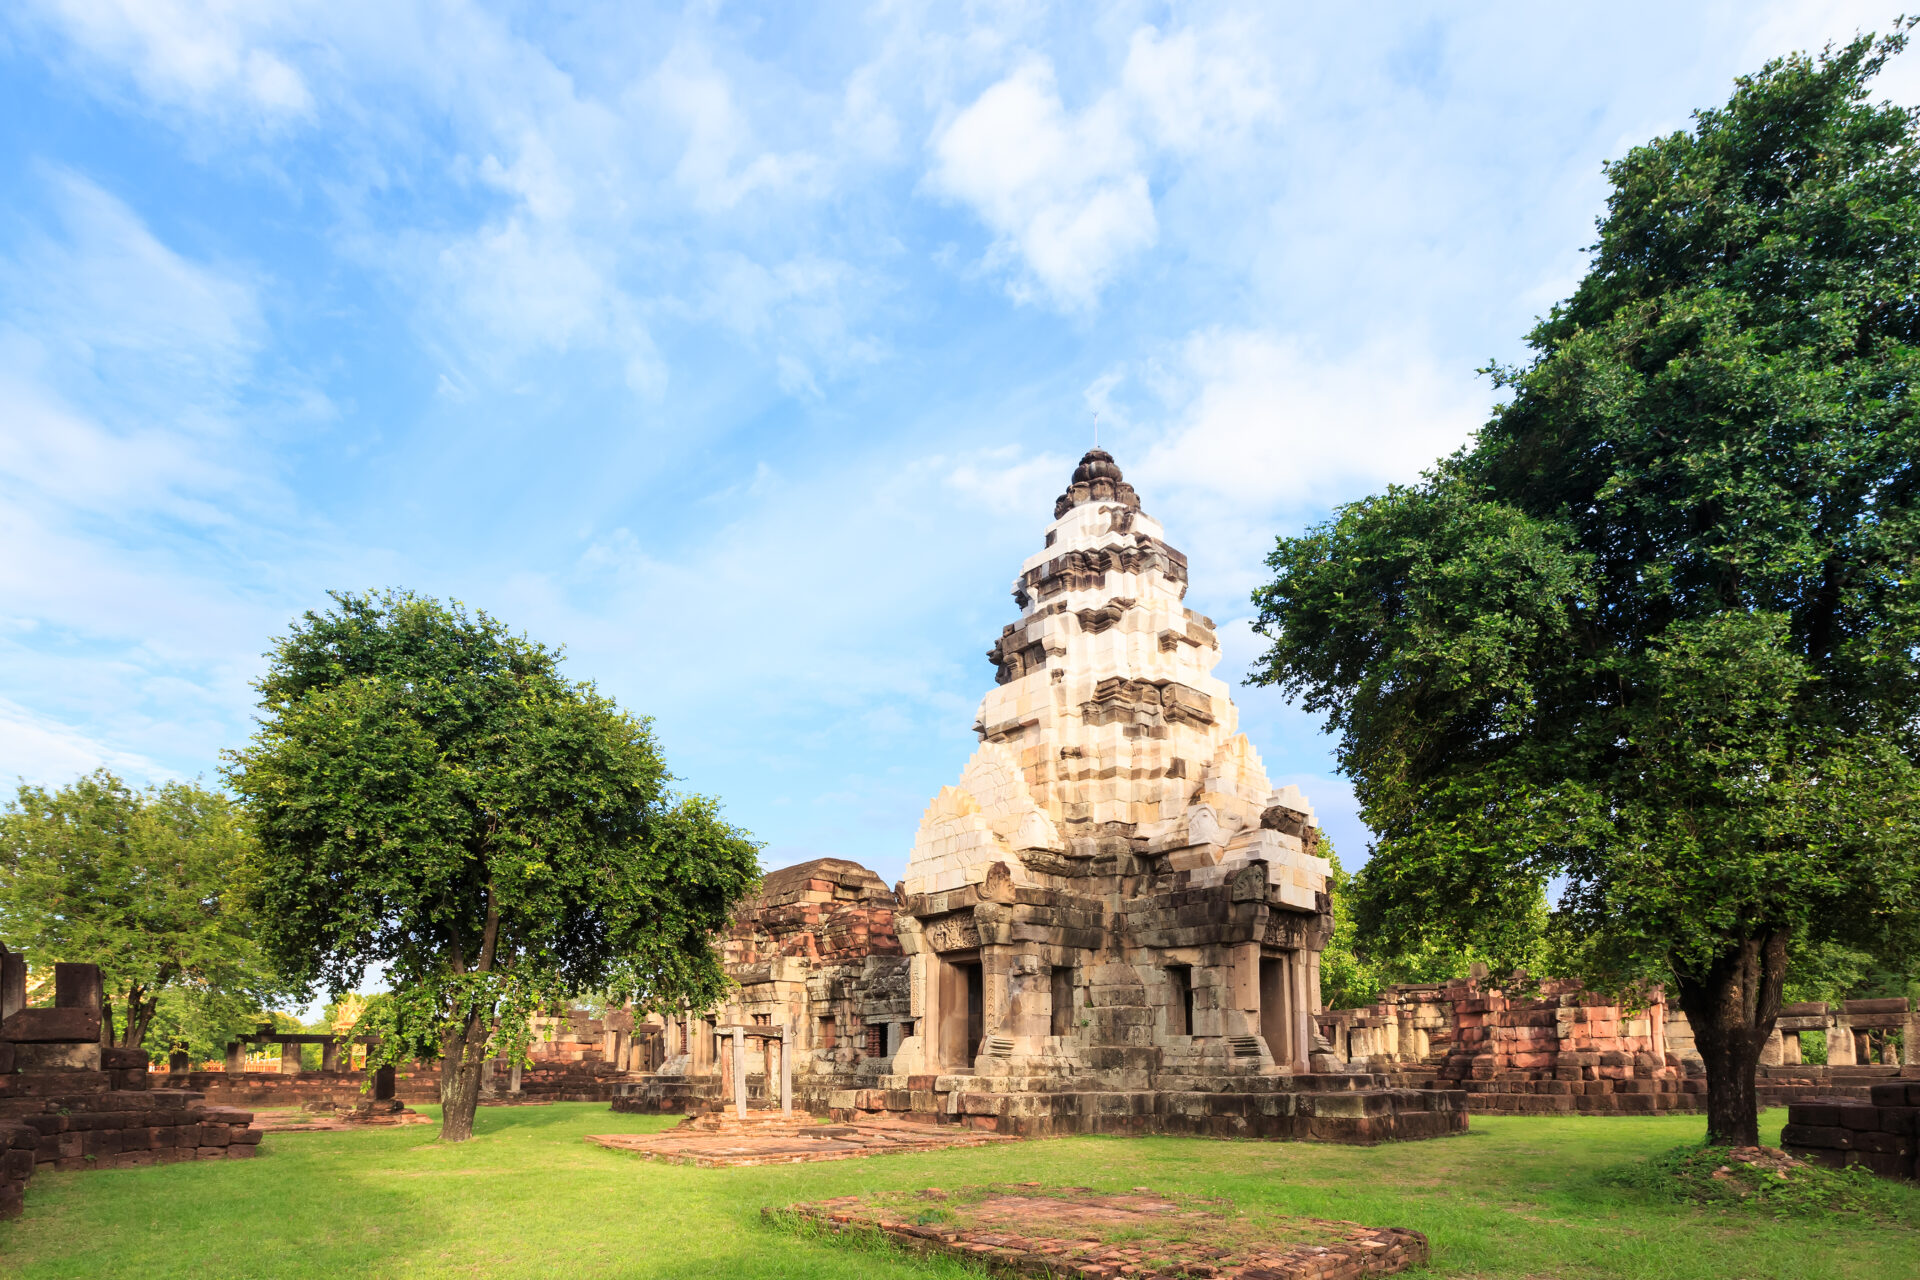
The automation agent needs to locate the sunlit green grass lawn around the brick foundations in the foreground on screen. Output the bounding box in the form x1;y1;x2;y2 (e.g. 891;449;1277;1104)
0;1103;1920;1280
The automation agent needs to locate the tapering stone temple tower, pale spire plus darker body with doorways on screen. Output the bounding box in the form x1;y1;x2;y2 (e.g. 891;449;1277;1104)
891;449;1444;1132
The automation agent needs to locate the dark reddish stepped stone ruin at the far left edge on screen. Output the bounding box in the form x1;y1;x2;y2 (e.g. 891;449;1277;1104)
0;946;261;1217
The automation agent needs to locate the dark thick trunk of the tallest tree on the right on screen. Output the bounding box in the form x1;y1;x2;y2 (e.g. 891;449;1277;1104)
1674;931;1788;1148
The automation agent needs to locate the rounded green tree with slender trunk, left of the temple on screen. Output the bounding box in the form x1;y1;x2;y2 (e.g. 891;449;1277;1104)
228;593;758;1142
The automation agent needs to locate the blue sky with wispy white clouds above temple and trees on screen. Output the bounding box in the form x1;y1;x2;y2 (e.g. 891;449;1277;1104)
0;0;1920;879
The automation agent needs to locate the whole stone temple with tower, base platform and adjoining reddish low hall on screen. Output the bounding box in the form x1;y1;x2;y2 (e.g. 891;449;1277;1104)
614;449;1467;1142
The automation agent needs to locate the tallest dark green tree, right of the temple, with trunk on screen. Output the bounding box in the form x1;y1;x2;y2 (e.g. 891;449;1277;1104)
1254;35;1920;1144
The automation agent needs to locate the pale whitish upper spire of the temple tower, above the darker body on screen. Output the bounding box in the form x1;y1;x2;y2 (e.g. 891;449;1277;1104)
904;449;1327;912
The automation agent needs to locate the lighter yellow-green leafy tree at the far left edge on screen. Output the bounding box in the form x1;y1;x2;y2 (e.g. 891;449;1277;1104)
0;770;280;1048
